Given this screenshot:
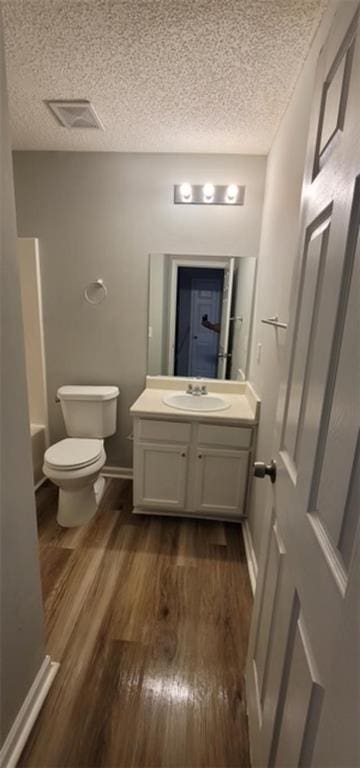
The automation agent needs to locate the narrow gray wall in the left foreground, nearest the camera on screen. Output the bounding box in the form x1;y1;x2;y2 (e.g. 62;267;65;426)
0;9;45;744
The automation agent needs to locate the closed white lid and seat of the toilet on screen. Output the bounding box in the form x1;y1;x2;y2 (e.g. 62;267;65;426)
45;437;103;469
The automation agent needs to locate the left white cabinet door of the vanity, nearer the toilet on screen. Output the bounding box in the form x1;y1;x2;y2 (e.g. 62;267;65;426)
134;443;188;511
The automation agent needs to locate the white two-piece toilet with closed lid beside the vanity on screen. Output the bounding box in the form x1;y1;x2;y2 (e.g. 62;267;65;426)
43;386;119;528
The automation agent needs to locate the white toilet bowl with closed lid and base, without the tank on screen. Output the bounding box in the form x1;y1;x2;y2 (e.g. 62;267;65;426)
43;437;106;528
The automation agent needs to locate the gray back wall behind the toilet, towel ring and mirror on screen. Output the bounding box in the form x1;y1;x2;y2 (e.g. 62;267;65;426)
14;148;266;466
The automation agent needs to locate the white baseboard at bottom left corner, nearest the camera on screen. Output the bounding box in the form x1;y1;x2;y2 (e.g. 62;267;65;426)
0;656;60;768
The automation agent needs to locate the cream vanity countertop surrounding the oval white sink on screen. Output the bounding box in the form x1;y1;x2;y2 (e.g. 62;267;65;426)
130;377;260;426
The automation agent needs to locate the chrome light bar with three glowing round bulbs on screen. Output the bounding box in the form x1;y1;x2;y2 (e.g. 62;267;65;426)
174;181;245;205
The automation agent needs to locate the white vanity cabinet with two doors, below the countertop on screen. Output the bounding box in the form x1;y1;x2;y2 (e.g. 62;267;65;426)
134;418;256;519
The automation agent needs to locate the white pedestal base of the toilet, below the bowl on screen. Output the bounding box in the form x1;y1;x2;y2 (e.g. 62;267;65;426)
56;477;106;528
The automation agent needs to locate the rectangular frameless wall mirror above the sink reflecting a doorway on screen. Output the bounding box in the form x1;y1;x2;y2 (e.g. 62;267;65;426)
147;253;256;381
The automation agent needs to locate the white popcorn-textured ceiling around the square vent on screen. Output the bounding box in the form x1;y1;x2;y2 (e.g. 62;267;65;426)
2;0;327;154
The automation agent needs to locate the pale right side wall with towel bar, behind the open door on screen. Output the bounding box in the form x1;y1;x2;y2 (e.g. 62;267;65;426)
249;3;335;559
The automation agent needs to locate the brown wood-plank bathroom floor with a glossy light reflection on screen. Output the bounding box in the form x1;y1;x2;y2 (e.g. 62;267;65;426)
20;480;252;768
